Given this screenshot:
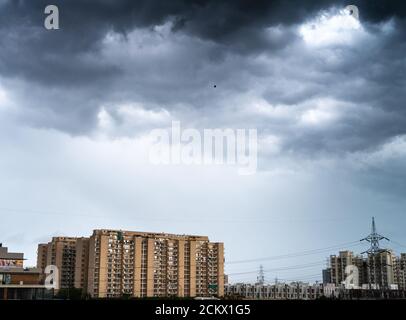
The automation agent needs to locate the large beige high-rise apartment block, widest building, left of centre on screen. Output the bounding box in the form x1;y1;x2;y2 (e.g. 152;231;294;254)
38;230;224;298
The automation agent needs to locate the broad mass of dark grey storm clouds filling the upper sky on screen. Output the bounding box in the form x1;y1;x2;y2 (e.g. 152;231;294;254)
0;0;406;153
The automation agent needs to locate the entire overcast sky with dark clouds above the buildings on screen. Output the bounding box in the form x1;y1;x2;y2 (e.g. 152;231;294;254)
0;0;406;281
